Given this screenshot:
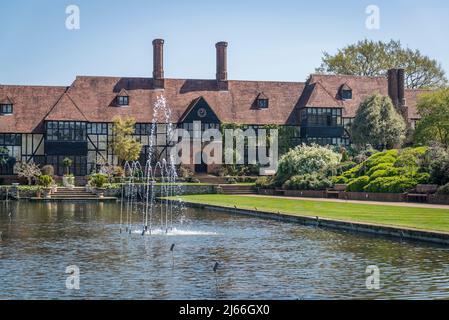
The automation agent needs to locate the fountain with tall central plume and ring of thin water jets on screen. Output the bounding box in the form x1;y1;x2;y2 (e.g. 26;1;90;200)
120;96;184;236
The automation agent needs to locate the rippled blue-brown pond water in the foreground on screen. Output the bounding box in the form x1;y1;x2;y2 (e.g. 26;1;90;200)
0;202;449;299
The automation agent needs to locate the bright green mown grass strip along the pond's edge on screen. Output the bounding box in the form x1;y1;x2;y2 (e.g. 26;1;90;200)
172;194;449;232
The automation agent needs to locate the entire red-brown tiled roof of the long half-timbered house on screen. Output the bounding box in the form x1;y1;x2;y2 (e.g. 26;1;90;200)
0;74;423;133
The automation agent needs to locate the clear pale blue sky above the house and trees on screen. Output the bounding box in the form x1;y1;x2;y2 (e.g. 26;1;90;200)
0;0;449;85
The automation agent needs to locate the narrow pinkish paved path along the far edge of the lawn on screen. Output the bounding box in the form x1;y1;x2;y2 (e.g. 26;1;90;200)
239;194;449;210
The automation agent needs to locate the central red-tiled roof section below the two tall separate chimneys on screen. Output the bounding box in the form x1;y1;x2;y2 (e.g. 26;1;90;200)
64;77;305;124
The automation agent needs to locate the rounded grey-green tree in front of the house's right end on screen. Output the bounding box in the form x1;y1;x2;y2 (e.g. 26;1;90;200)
350;93;406;150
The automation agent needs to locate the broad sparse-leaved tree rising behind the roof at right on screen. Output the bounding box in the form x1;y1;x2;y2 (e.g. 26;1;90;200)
316;39;447;89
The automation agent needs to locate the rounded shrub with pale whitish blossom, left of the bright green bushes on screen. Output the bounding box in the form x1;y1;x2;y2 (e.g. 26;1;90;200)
275;144;341;185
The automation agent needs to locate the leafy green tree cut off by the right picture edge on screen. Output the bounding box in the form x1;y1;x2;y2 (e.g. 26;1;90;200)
415;89;449;148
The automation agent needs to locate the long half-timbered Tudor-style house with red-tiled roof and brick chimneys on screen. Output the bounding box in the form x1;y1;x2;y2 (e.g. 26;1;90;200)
0;39;426;176
